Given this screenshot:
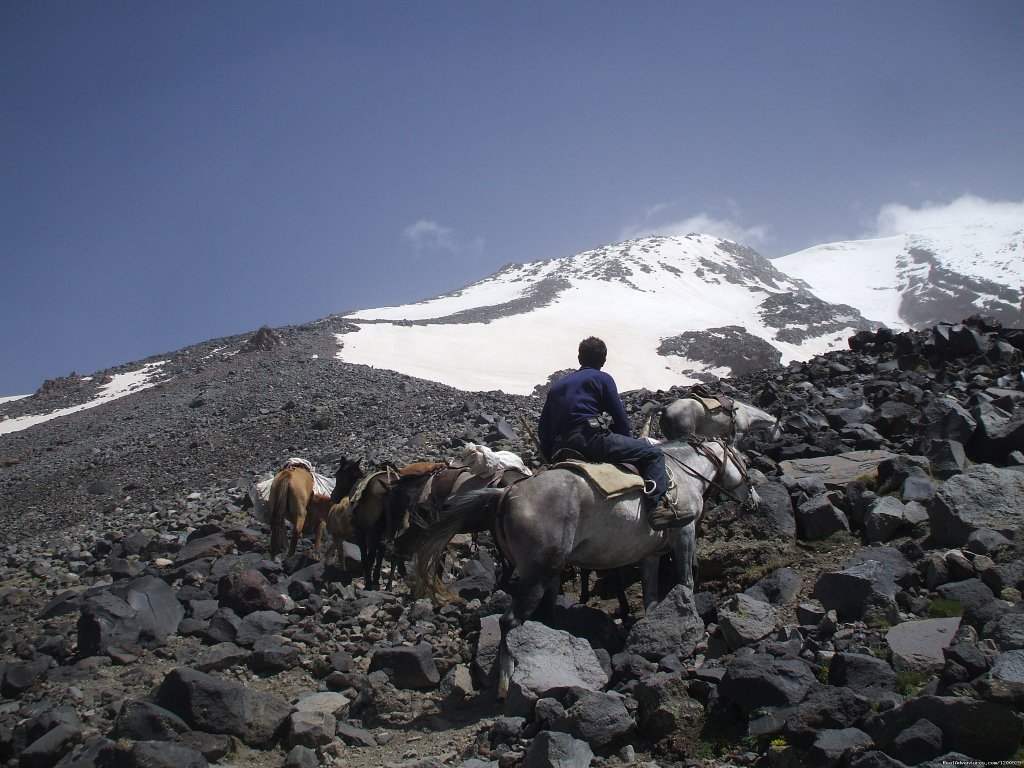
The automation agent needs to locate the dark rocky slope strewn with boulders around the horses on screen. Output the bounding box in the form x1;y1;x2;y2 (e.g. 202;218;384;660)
0;318;1024;767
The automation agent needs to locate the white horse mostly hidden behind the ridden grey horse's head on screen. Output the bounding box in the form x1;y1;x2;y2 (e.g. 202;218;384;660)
658;396;782;442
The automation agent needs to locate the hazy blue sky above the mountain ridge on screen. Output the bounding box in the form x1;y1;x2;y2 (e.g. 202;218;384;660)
0;0;1024;395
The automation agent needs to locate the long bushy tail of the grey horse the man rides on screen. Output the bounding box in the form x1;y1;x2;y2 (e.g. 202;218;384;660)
413;488;505;601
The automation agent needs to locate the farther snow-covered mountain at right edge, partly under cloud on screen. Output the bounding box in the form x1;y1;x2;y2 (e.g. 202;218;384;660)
772;212;1024;330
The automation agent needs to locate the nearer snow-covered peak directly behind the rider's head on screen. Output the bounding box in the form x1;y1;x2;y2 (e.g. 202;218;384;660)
338;234;868;394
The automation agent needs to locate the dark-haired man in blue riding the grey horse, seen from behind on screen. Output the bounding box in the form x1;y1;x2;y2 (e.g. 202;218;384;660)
538;336;685;530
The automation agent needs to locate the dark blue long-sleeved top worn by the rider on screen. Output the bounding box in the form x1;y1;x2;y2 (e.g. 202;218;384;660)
538;368;632;457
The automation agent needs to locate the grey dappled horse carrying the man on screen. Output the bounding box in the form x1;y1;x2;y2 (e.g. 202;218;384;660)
416;441;757;697
